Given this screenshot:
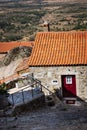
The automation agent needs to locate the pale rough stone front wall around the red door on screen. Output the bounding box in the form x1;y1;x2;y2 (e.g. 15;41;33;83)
30;66;87;101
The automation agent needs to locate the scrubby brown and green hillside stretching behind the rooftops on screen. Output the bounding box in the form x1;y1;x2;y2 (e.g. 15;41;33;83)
0;0;87;41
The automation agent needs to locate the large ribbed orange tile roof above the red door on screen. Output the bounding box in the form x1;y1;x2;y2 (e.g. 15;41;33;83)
28;31;87;66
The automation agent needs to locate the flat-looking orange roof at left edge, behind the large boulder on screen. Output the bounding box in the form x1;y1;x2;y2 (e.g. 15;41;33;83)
0;41;34;53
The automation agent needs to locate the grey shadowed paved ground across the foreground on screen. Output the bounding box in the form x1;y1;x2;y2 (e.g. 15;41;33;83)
0;101;87;130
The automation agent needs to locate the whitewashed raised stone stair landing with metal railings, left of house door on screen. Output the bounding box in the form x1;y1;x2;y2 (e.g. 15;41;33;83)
0;75;58;115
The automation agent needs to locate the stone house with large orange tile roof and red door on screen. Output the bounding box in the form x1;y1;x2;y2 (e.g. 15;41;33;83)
28;31;87;101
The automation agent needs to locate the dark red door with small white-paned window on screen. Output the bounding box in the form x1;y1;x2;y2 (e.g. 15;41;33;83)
62;75;76;97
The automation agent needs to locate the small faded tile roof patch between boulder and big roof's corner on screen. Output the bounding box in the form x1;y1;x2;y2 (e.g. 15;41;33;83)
15;58;29;72
